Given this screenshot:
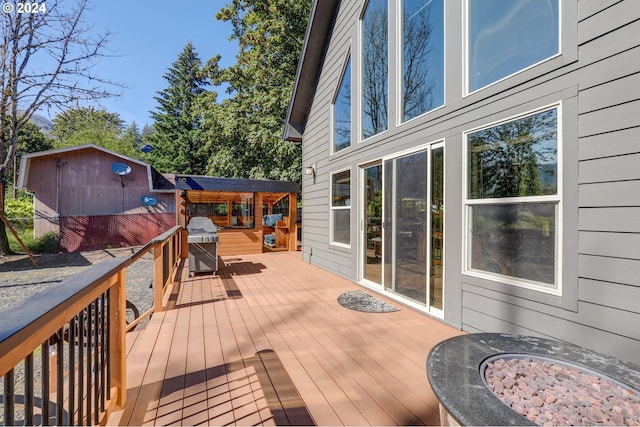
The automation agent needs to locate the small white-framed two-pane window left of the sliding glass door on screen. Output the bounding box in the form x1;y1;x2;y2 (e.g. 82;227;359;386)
330;170;351;246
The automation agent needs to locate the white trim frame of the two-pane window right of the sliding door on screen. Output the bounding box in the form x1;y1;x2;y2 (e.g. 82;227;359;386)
462;101;564;296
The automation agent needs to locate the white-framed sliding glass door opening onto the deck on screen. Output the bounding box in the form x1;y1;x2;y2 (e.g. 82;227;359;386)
360;143;444;314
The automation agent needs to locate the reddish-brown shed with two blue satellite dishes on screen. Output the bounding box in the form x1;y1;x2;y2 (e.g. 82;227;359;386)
18;144;176;252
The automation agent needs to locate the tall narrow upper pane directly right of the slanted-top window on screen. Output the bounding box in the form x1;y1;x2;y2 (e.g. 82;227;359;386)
362;0;389;139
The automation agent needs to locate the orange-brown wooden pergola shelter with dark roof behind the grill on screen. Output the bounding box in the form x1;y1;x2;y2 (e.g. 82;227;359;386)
176;175;300;255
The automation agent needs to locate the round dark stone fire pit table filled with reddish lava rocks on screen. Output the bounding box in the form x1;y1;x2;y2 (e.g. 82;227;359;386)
427;333;640;425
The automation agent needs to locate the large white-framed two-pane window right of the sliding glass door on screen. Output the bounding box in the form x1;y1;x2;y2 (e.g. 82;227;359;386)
466;107;561;292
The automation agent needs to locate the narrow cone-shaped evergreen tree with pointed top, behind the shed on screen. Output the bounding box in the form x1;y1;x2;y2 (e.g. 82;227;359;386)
145;42;209;174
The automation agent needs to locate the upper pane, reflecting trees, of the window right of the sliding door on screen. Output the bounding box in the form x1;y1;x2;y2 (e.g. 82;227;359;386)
467;108;558;199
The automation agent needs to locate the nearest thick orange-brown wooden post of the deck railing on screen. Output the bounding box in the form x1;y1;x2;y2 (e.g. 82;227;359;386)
109;269;127;409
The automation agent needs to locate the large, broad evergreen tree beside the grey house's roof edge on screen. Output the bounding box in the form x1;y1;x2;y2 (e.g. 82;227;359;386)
201;0;312;181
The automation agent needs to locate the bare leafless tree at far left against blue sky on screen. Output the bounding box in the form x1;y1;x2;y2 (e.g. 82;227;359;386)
0;0;119;254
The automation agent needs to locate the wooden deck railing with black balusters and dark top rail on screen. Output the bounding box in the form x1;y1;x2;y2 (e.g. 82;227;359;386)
0;226;183;425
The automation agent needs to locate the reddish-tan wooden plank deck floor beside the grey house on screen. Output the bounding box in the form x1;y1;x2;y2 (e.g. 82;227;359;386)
109;252;461;425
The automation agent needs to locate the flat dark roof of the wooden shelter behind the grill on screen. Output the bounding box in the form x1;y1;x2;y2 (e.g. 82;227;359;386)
176;175;300;193
